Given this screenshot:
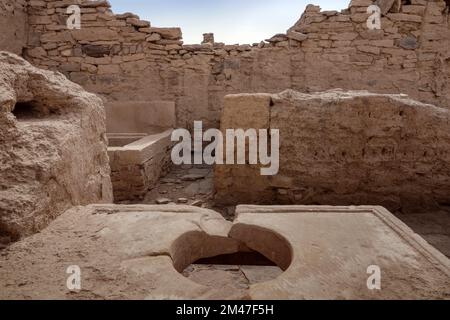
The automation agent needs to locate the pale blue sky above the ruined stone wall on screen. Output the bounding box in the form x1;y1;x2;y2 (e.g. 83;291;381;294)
110;0;350;44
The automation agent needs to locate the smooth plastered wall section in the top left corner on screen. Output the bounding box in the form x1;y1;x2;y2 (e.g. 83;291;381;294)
0;0;28;54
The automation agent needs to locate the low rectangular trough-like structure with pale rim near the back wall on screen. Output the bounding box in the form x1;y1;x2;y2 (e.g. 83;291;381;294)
105;100;176;201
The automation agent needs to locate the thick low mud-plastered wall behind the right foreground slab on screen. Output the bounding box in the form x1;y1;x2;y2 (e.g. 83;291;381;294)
215;90;450;213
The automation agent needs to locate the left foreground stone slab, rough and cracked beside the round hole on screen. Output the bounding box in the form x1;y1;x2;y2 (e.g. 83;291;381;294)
0;206;238;299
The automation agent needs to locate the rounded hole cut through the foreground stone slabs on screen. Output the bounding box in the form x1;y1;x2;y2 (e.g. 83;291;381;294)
171;225;292;297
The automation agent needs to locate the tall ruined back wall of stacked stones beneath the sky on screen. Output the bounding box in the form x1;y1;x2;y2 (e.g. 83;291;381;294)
14;0;450;127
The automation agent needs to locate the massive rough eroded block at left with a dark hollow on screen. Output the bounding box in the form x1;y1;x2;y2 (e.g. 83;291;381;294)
0;52;112;242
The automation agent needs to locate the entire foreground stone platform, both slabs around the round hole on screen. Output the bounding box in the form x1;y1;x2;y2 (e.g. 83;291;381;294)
0;205;450;299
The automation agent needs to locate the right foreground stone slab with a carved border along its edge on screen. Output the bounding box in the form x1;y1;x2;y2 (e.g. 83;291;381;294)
232;206;450;299
